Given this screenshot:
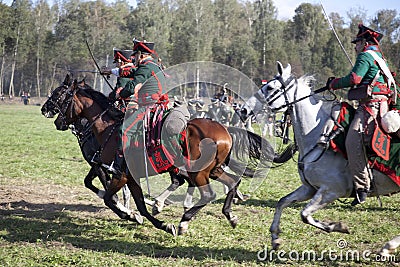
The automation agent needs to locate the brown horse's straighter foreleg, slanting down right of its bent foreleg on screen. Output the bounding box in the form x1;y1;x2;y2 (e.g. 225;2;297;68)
127;177;176;236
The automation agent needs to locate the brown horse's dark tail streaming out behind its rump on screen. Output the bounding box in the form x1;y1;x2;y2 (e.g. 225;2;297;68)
225;127;280;177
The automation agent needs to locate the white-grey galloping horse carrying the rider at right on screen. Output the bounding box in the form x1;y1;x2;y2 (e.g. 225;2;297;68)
241;62;400;254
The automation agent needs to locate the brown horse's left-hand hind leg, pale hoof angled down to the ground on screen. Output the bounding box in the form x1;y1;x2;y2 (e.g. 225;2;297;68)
178;183;217;235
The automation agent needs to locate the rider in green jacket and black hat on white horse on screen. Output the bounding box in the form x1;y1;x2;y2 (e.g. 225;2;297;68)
320;24;396;206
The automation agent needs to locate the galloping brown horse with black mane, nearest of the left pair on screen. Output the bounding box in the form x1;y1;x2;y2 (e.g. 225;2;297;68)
42;75;275;235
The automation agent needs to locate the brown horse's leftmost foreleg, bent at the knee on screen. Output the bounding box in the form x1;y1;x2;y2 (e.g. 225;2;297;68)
103;175;143;224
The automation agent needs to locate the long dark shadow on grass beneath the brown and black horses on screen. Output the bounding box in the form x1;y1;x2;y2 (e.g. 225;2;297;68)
0;201;257;262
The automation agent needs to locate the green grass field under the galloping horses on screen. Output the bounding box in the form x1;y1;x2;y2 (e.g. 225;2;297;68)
0;104;400;266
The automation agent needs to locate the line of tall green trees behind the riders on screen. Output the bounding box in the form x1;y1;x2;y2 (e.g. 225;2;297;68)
0;0;400;97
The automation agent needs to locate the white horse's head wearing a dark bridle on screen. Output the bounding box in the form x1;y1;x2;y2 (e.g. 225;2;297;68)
240;61;296;120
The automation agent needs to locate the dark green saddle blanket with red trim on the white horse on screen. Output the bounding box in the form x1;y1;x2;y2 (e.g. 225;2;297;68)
329;102;400;186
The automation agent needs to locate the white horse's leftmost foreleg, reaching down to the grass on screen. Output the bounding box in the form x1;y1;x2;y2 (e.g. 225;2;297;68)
269;185;315;250
